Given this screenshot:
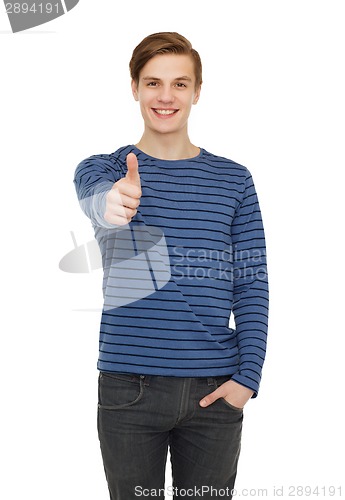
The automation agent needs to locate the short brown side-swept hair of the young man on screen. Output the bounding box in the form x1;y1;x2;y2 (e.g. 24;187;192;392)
129;31;202;89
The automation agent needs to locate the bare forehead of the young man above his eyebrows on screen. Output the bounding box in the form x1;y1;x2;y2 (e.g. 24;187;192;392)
140;54;195;80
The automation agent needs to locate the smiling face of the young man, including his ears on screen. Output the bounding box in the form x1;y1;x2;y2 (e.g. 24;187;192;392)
132;54;200;134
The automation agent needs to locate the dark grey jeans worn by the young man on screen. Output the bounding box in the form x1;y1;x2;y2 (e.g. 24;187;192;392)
98;372;243;500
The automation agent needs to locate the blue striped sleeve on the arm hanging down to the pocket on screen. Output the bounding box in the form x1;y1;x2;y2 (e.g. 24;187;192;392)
231;172;268;397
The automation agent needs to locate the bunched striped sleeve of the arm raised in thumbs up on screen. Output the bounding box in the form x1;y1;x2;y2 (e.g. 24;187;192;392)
74;154;125;229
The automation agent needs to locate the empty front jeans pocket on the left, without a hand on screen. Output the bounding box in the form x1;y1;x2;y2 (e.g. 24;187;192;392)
98;372;144;410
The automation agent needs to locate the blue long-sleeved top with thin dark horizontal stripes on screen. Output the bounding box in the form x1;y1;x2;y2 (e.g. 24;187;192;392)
74;145;268;397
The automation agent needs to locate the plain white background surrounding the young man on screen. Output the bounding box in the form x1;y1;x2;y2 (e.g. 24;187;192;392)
0;0;345;500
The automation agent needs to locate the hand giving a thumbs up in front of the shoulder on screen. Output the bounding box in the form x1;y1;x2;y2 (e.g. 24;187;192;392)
104;153;142;226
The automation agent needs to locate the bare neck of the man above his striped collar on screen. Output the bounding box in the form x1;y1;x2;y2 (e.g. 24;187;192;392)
135;130;200;160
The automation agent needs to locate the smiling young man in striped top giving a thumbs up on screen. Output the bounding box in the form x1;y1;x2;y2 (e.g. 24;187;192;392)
74;32;268;500
